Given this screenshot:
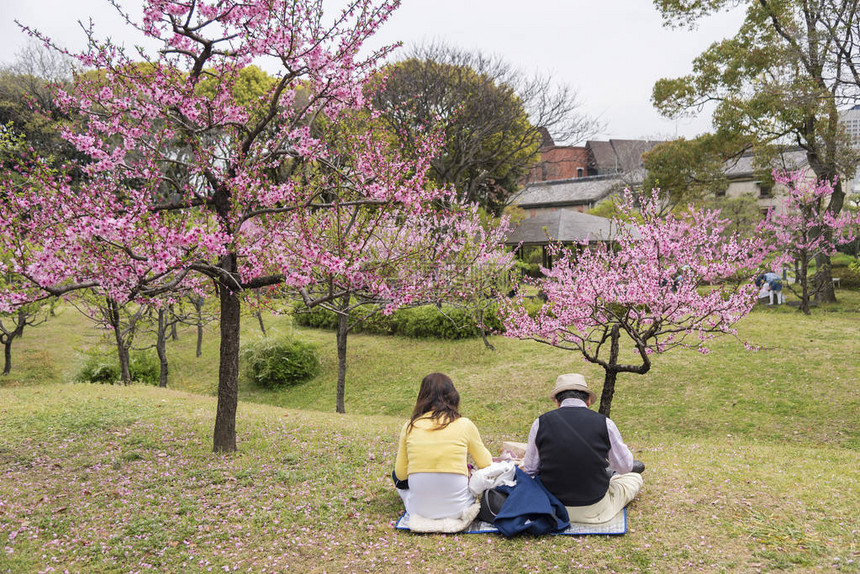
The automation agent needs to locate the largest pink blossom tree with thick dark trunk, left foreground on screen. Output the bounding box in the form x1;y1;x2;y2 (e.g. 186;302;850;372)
0;0;478;451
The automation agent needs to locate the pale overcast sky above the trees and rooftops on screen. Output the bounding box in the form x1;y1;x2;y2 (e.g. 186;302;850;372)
0;0;743;139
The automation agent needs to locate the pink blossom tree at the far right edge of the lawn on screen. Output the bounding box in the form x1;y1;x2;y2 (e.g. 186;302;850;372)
758;170;860;315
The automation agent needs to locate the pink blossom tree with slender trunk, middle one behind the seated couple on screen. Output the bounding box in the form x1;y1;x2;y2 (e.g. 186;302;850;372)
300;197;512;413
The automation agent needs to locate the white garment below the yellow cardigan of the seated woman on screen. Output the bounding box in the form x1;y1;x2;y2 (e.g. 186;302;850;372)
397;472;475;518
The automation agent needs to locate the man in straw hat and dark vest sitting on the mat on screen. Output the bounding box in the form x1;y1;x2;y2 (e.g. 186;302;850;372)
523;373;645;524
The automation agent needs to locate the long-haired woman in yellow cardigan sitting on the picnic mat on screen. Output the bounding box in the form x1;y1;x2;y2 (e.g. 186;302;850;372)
394;373;493;519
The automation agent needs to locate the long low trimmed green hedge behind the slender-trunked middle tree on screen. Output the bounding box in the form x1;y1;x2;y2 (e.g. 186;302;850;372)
294;301;540;340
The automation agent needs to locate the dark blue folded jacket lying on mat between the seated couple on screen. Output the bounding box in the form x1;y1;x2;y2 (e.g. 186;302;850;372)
493;468;570;536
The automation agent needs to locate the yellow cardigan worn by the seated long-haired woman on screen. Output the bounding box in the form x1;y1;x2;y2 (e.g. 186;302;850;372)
394;414;493;480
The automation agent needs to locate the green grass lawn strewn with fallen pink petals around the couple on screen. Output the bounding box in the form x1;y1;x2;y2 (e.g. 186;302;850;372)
0;290;860;572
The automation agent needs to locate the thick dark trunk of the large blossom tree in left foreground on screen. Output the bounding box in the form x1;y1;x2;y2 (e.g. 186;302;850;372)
212;270;241;452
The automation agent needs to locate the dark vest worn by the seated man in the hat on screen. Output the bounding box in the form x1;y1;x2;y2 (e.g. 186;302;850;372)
535;407;610;506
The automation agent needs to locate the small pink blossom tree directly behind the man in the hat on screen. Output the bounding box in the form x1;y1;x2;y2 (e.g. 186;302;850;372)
504;191;765;416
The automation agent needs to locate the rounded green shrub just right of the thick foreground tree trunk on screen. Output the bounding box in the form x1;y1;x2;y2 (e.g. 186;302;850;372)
241;338;320;389
